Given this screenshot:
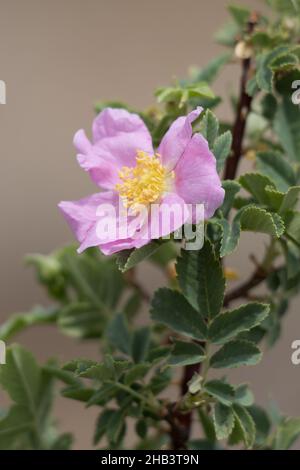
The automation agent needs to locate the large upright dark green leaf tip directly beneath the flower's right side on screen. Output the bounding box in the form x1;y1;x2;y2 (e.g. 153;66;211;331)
176;241;225;319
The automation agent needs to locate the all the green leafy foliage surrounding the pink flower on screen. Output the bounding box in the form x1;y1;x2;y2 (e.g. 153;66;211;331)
0;0;300;450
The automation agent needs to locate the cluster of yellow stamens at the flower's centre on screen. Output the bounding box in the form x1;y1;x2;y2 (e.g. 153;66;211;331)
115;150;174;210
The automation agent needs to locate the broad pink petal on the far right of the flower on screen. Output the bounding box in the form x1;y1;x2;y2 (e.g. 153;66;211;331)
175;134;224;219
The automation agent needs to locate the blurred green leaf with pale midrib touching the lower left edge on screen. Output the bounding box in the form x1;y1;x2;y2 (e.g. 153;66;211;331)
0;345;40;414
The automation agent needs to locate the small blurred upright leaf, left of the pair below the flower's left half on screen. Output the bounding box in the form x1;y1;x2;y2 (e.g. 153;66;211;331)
106;313;132;356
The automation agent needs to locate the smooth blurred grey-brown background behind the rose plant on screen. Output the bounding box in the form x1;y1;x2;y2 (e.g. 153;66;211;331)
0;0;300;449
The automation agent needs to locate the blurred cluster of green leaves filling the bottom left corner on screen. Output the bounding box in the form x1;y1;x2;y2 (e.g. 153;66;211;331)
0;345;72;450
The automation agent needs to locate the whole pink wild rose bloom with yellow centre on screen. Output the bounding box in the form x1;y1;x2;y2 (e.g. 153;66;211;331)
59;107;224;255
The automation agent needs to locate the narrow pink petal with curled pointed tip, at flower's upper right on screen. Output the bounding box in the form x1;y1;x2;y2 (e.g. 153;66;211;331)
158;106;202;170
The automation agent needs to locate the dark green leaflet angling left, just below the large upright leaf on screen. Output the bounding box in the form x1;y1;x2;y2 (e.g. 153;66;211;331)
151;288;207;340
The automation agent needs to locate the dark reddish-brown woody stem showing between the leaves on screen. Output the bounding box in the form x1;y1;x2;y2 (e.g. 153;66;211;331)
168;13;258;449
